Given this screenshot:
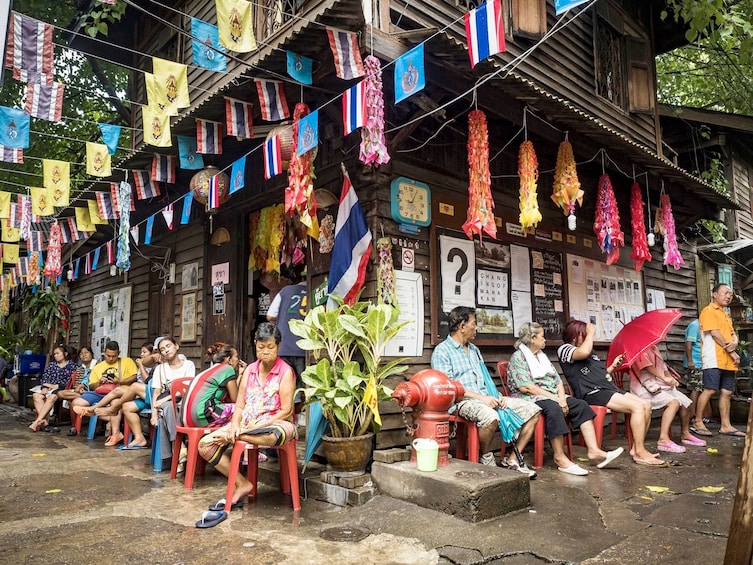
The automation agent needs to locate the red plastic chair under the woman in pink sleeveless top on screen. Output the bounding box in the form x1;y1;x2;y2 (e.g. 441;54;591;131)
225;439;301;512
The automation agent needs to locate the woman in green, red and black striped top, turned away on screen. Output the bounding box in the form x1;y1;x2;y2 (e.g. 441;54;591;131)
181;343;246;428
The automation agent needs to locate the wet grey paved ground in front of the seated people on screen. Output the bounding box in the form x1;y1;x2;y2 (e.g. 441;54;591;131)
0;405;743;565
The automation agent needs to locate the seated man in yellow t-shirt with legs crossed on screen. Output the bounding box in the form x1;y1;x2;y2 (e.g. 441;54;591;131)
71;341;138;447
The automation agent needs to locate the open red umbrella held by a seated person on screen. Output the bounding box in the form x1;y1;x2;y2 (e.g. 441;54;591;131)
607;308;682;369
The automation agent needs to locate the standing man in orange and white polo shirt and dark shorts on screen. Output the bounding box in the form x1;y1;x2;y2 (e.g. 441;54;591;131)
693;284;745;437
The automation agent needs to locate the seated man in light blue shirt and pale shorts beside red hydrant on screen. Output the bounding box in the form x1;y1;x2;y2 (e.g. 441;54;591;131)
431;306;541;478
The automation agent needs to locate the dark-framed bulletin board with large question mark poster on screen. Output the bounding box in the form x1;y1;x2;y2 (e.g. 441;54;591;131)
432;228;565;345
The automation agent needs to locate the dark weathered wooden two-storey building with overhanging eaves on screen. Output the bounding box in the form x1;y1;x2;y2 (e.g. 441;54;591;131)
63;0;736;446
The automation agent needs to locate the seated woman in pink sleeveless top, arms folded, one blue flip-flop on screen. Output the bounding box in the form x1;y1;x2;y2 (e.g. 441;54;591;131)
196;322;297;528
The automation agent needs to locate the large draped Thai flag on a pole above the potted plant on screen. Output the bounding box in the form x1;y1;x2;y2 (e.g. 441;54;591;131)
327;170;371;308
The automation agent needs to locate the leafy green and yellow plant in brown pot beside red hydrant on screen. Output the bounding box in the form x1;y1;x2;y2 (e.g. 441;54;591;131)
290;297;408;472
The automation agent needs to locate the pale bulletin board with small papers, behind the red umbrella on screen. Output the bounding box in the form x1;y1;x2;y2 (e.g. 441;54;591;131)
567;253;646;341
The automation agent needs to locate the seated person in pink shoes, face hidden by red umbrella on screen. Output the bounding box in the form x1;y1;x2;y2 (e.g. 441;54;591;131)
630;345;706;453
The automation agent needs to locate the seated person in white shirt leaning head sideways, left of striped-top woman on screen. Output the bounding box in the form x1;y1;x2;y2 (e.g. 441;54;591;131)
122;337;196;450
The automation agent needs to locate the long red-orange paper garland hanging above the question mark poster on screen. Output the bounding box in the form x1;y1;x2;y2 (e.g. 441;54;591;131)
463;110;497;239
